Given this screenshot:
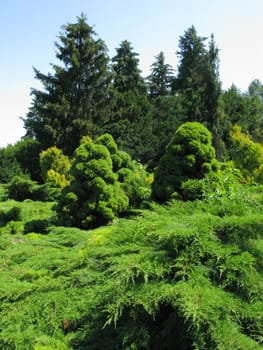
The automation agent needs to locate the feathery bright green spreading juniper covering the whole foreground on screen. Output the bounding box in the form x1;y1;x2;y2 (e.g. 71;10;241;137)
0;190;263;350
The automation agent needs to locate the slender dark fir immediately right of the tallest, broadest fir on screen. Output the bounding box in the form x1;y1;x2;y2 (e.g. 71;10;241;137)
104;40;153;164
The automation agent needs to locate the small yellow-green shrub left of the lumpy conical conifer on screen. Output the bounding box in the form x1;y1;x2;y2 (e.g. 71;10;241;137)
40;146;71;188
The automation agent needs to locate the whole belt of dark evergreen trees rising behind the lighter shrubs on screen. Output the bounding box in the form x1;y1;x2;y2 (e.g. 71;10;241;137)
0;15;263;182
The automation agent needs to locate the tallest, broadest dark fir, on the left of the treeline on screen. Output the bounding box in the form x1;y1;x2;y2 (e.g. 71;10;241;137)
23;14;111;154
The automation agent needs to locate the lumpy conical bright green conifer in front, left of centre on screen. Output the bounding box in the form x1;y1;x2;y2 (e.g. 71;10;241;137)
57;133;128;227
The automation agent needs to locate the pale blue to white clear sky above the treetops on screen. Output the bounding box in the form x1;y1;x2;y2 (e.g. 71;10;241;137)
0;0;263;147
